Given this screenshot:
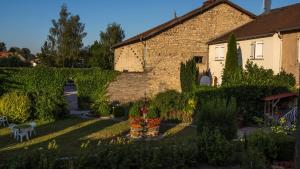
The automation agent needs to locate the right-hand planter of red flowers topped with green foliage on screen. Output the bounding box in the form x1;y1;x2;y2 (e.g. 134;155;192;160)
145;104;160;137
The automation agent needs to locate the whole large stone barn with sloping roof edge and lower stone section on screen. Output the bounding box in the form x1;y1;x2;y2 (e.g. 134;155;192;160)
108;0;256;102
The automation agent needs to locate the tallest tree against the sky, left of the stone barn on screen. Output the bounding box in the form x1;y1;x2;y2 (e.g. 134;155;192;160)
48;5;87;67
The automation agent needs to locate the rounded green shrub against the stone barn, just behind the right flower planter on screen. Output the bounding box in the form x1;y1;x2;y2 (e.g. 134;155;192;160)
153;90;184;120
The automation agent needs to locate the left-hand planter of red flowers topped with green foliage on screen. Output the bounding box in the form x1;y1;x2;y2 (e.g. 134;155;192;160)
129;103;144;138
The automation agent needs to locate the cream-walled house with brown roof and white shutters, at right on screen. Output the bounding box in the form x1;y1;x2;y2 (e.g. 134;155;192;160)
209;3;300;86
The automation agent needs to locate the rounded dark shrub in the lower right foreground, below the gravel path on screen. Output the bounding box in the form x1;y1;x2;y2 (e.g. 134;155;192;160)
246;130;277;160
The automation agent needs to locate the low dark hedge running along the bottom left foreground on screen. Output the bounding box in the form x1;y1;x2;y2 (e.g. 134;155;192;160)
0;139;198;169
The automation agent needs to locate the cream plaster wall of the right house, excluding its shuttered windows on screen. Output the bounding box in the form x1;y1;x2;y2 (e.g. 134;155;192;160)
208;33;282;85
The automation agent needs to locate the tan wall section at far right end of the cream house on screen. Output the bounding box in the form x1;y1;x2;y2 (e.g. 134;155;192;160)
282;32;300;87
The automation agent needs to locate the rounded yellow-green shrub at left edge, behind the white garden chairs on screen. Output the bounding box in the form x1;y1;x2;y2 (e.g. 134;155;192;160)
0;92;31;123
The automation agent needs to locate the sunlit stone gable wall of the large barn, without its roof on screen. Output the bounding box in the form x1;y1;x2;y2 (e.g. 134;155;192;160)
111;4;252;101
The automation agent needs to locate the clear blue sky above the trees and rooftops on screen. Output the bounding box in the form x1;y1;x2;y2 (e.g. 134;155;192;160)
0;0;300;53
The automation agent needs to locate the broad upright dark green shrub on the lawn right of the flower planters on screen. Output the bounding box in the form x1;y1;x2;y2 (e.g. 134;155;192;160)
197;97;237;139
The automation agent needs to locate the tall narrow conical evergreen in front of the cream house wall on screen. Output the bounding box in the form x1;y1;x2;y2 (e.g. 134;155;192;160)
222;34;242;86
